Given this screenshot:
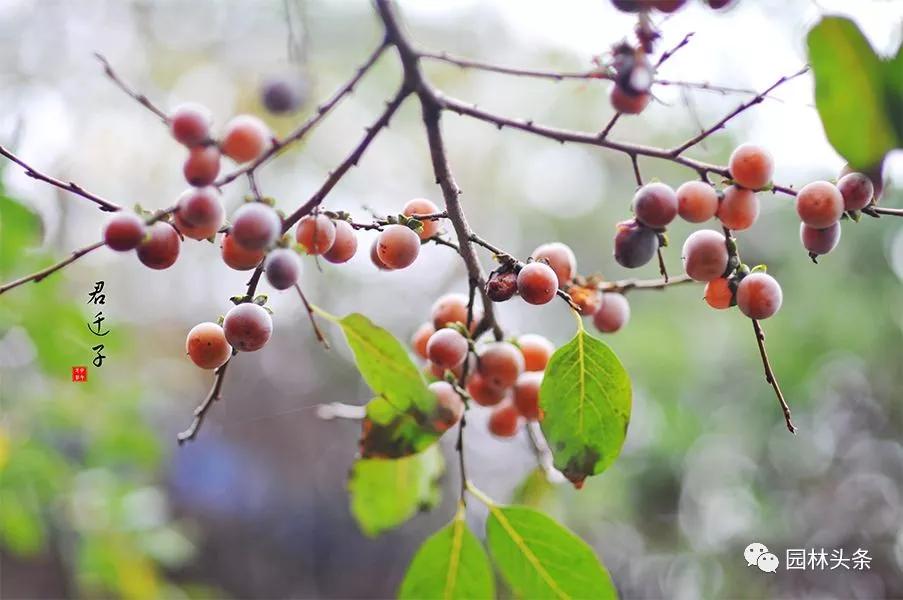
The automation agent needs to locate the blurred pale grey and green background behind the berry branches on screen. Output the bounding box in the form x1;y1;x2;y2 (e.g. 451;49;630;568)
0;0;903;598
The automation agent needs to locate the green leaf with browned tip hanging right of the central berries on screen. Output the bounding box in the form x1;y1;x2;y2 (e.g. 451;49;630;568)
539;325;631;487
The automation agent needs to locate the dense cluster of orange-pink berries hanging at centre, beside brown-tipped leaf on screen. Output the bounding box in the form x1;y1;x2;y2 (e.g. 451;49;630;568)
411;294;555;437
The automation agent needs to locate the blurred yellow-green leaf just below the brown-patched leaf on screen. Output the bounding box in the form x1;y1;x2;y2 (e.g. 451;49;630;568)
348;445;445;536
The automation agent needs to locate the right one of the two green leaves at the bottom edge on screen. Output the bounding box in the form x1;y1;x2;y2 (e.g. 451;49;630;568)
486;505;617;599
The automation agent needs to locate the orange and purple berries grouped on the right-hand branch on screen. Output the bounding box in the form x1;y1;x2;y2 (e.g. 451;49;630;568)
614;144;875;319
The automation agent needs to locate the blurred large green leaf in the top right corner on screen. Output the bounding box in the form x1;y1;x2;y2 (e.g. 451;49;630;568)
807;17;903;170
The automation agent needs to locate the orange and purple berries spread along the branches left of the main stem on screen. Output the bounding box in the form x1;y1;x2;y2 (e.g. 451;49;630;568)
103;99;452;369
